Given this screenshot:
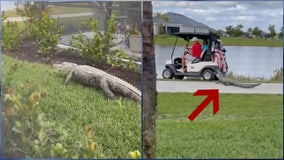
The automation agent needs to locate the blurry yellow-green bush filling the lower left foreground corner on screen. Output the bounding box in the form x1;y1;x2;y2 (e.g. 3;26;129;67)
1;64;103;158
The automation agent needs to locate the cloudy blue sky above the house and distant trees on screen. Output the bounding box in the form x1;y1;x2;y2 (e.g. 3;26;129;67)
152;0;283;32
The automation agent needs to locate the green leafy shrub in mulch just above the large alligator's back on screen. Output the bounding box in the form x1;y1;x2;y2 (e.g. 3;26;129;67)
71;14;140;72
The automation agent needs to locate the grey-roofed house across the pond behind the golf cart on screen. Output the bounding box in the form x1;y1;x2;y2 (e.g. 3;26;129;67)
154;12;210;35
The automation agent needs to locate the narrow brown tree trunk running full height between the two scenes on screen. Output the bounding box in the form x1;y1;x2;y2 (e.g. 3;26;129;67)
142;1;157;159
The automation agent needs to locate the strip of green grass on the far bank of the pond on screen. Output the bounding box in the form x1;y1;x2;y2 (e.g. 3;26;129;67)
154;36;283;47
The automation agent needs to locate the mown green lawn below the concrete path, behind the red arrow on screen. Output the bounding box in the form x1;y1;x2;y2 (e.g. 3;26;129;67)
156;93;283;158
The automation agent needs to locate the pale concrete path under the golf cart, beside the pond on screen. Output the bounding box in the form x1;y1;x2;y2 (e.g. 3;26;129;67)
157;80;283;94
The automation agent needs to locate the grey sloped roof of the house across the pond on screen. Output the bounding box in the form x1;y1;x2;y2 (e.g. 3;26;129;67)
154;12;210;29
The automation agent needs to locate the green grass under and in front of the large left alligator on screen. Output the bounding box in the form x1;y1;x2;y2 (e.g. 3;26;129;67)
2;55;141;158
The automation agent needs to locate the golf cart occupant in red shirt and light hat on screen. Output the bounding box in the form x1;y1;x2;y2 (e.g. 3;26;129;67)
177;37;202;73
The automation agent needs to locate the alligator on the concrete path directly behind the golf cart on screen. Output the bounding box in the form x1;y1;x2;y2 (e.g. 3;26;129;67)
216;69;260;88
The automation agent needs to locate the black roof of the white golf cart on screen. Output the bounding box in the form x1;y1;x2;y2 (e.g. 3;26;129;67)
173;32;220;41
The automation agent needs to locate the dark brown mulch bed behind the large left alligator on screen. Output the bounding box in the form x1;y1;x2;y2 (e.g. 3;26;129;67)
2;40;141;89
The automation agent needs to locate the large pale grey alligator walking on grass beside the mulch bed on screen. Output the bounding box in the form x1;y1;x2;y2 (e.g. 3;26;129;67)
53;62;141;102
